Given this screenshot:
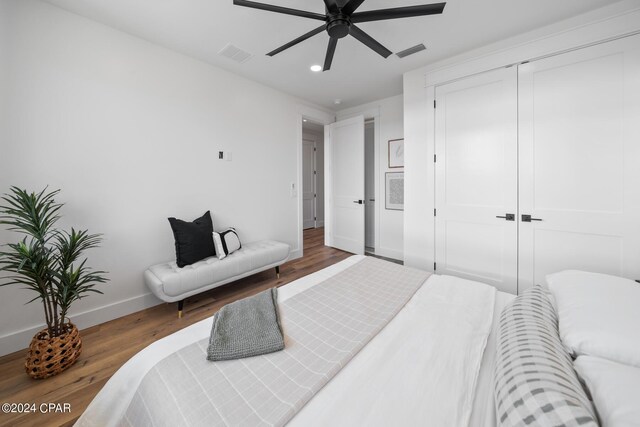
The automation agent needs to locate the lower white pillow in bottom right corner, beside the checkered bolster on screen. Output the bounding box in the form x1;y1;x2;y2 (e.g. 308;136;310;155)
573;356;640;427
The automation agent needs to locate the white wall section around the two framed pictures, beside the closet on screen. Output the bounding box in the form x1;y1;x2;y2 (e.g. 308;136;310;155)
337;95;406;260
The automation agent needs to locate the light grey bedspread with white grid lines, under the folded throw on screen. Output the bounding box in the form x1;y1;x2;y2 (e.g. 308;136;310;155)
120;258;429;426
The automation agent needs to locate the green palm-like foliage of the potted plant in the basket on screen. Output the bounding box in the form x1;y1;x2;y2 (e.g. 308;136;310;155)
0;187;108;336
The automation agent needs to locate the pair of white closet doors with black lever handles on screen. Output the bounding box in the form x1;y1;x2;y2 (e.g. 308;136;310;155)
435;36;640;293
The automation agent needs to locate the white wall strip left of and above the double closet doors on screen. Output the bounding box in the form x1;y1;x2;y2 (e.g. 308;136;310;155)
403;0;640;271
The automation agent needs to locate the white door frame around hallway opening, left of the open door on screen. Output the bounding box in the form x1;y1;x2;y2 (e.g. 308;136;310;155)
296;105;336;259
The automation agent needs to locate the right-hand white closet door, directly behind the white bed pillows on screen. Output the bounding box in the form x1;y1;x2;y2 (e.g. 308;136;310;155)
518;36;640;292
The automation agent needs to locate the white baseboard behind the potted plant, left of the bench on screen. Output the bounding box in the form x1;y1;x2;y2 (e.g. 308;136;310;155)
0;293;162;356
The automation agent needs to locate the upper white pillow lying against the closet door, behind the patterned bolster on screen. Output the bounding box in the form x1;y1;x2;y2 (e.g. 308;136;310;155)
546;270;640;367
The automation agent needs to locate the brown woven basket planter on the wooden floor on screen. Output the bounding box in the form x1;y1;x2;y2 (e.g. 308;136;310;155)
24;322;82;379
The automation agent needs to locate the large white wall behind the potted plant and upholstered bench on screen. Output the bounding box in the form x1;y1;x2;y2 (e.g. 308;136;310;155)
0;0;330;354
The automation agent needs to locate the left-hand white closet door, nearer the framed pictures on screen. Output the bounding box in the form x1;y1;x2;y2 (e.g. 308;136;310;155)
434;67;518;293
